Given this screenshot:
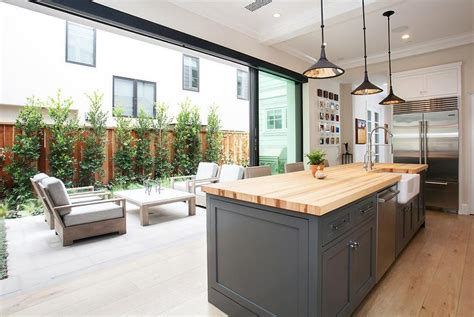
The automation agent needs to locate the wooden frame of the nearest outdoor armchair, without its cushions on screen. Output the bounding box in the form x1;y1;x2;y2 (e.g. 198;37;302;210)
38;184;127;246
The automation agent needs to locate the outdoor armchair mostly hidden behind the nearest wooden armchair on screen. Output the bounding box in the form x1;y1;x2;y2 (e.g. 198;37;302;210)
30;173;110;230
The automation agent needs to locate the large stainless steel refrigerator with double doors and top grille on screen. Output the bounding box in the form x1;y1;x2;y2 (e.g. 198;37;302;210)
392;97;459;212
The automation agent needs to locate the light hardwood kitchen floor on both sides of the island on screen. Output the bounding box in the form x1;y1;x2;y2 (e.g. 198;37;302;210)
0;212;474;316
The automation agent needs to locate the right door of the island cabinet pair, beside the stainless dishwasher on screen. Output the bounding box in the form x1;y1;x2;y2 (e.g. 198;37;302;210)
349;217;376;309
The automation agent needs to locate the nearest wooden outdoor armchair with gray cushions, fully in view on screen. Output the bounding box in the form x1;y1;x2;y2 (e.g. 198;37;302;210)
38;177;127;246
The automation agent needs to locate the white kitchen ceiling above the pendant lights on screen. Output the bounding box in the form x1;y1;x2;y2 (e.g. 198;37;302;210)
97;0;474;67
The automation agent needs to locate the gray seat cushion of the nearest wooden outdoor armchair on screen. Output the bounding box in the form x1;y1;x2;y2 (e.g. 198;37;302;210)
63;203;123;227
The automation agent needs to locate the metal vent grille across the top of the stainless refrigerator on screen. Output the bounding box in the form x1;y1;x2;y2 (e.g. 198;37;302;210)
393;97;458;114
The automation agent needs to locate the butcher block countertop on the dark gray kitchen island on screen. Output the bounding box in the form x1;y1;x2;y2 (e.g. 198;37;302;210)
202;163;428;216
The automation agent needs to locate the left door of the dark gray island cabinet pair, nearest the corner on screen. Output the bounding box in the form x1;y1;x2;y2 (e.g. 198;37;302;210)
321;235;352;316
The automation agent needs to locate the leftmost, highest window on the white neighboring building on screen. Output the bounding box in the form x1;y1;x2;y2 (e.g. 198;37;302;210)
66;22;96;67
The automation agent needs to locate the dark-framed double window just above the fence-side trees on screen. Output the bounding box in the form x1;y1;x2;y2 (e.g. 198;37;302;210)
113;76;156;117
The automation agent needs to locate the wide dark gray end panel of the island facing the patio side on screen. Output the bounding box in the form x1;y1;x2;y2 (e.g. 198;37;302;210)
207;198;316;317
